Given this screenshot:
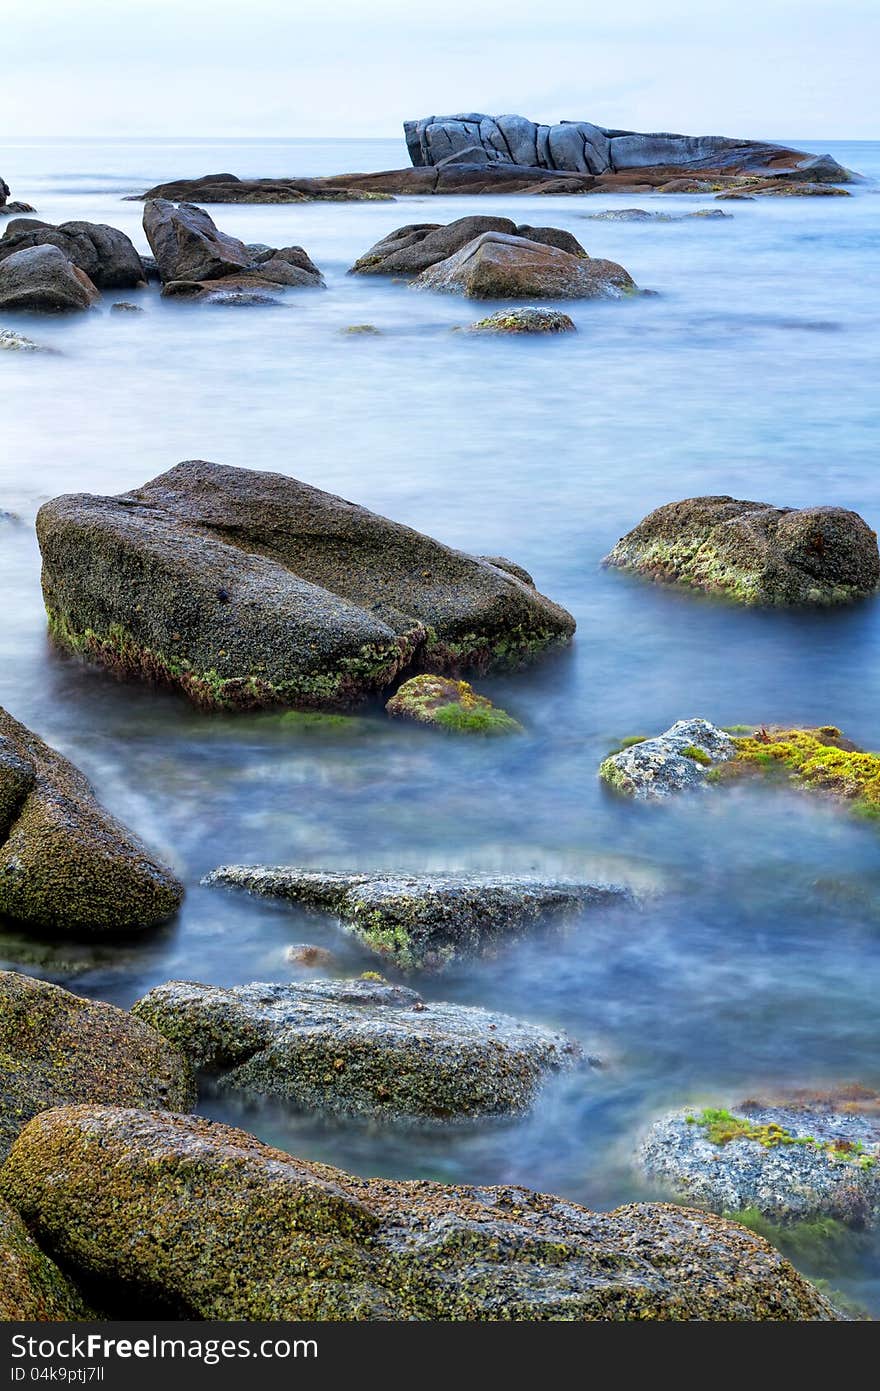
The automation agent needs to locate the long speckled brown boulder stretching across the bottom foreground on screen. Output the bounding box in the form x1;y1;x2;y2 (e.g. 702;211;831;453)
0;1106;837;1321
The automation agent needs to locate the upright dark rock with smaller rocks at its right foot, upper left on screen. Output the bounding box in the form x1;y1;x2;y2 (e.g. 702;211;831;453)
143;199;324;299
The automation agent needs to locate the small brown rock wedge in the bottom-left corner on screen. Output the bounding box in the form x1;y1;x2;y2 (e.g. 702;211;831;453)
0;1202;97;1323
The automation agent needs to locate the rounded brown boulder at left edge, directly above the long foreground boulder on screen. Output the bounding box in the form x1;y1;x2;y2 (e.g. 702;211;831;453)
0;971;196;1159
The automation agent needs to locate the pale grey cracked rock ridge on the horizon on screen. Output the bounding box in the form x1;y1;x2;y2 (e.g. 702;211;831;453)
403;113;849;184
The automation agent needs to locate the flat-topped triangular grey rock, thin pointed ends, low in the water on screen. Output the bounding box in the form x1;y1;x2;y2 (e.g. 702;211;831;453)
204;865;631;971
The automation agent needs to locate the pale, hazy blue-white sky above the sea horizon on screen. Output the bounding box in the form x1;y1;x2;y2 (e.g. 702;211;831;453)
0;0;880;141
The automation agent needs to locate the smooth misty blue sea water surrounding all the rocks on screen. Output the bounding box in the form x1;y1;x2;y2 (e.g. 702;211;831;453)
0;140;880;1310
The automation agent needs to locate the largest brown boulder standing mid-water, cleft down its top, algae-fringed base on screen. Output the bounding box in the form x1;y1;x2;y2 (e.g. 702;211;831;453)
36;460;574;709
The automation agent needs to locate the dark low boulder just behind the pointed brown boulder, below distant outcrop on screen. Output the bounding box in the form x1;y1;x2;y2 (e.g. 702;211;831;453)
350;217;587;275
